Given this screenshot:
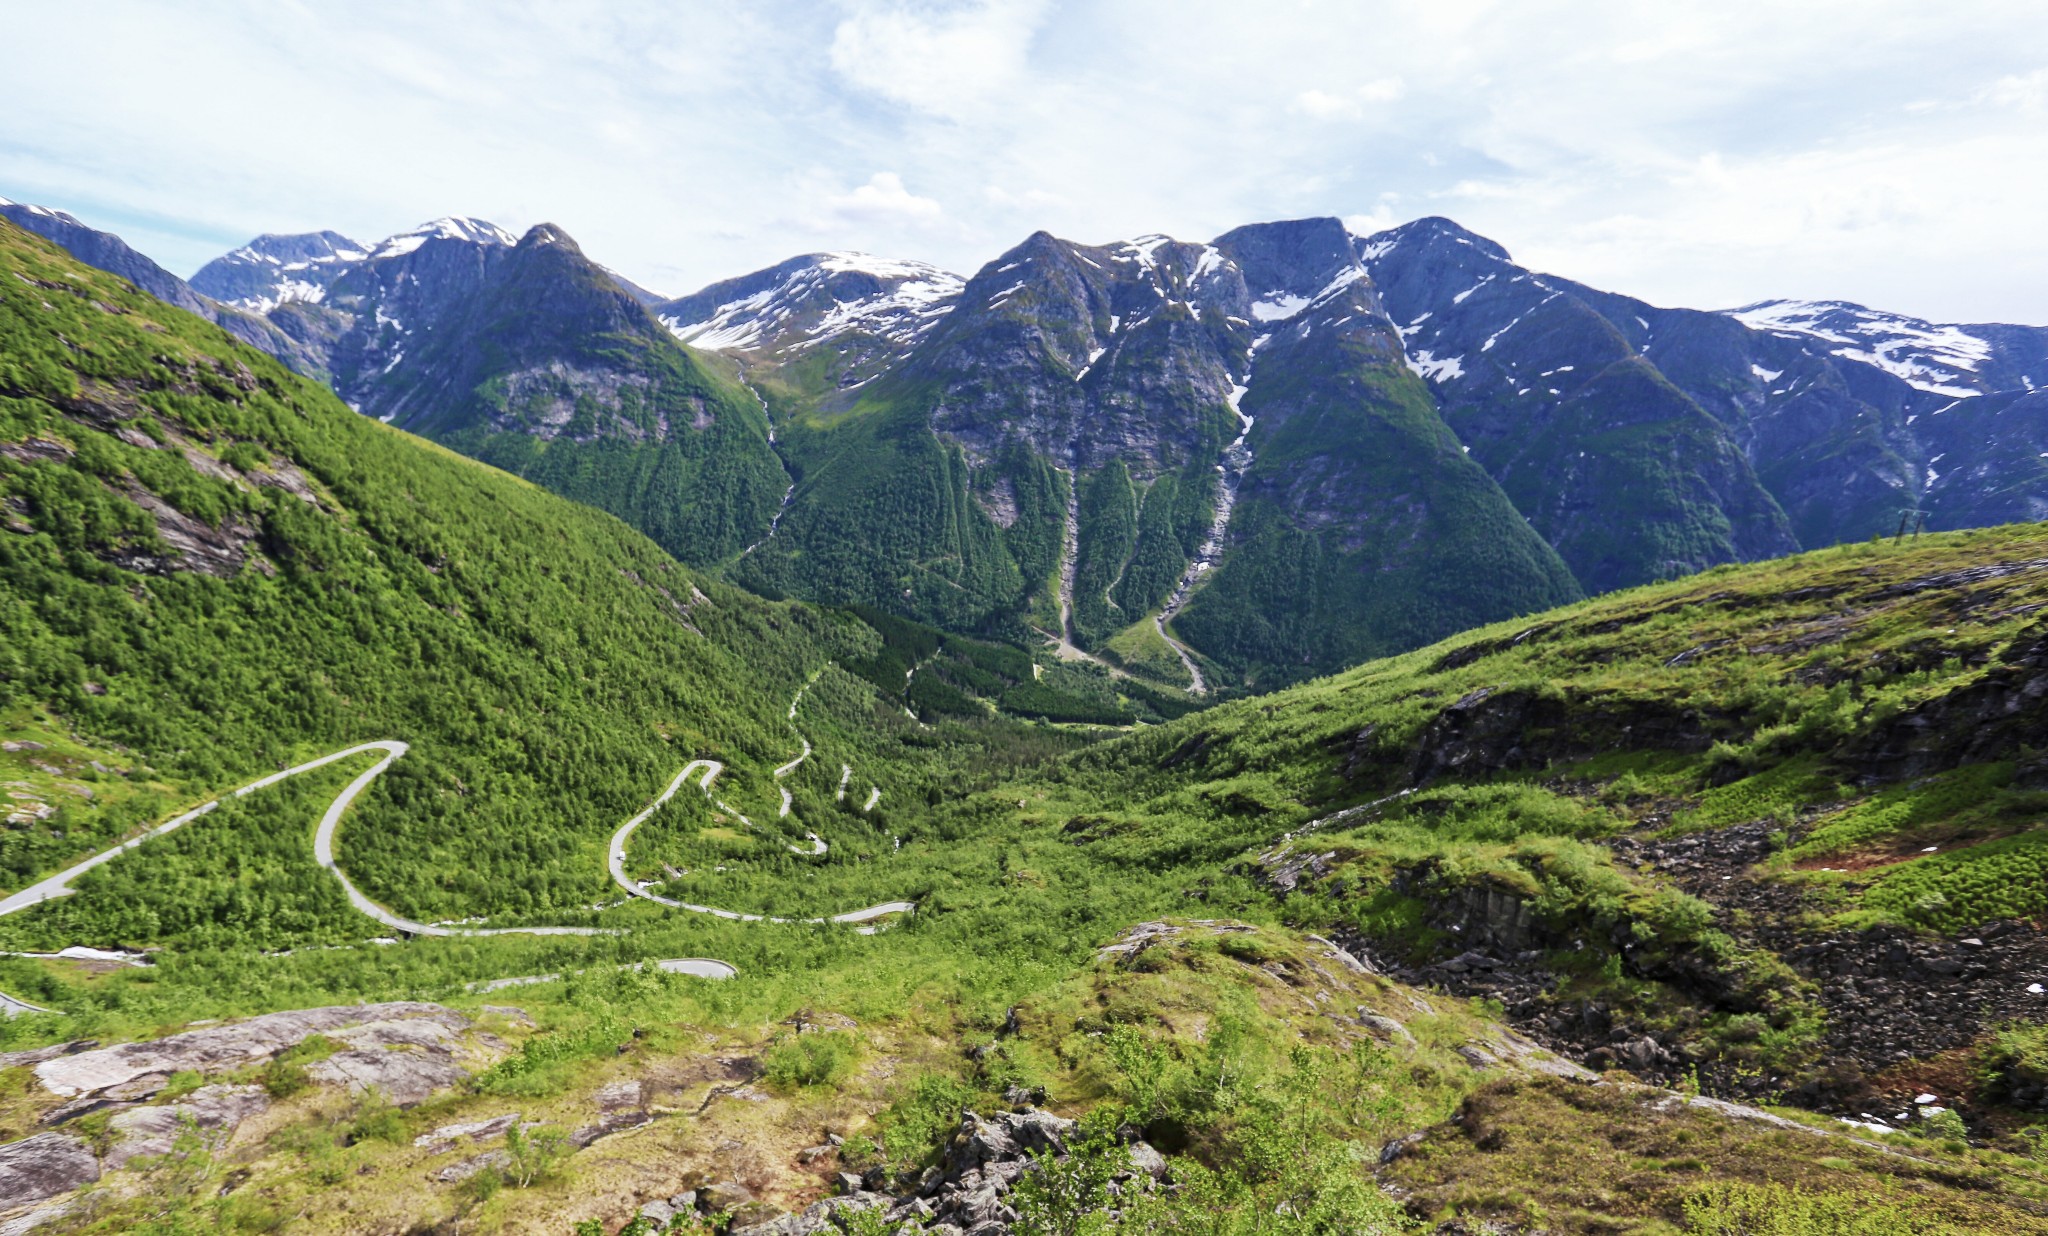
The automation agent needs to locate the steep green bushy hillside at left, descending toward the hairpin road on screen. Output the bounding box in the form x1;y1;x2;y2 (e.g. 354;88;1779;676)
0;216;874;943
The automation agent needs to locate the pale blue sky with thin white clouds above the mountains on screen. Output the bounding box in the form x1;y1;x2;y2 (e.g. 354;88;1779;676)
0;0;2048;323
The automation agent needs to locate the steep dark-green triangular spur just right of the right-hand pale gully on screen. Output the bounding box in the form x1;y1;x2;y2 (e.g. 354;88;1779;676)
1178;219;1579;677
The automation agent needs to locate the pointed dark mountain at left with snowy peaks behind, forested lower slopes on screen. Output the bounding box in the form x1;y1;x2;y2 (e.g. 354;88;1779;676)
186;217;788;563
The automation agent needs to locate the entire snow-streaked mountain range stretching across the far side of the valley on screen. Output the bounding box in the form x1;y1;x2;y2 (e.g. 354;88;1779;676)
6;197;2048;690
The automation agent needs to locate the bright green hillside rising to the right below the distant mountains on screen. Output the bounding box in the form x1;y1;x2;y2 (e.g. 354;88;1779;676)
1069;526;2048;929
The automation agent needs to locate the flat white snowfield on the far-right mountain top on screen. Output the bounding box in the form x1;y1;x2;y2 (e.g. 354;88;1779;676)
1724;301;1993;399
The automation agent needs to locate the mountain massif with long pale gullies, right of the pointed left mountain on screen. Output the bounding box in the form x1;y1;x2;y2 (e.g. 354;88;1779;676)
696;209;2048;677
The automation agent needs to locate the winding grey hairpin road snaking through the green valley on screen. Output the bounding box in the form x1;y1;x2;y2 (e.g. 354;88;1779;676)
0;695;918;1017
